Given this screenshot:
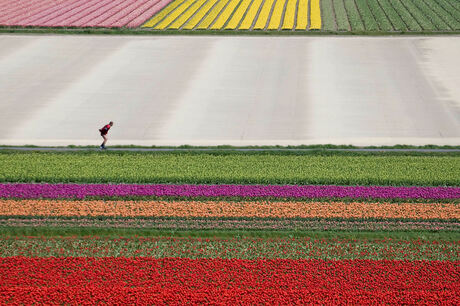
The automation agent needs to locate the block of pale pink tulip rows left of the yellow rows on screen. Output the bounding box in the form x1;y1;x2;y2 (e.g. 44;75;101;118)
0;0;172;28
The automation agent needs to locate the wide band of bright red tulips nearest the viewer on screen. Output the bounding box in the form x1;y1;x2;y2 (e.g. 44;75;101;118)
0;257;460;305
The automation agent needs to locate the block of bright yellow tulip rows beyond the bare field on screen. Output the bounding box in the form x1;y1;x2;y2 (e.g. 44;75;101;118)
143;0;321;30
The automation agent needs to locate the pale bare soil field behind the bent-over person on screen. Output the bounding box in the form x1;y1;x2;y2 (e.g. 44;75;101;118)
0;35;460;146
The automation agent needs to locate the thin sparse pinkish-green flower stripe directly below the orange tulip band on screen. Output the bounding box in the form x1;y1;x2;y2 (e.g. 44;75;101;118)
0;217;460;232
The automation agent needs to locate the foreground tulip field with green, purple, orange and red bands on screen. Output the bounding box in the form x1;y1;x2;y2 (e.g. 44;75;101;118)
0;150;460;305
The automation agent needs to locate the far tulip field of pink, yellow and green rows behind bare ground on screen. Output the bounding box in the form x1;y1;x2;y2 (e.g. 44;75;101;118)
0;0;460;33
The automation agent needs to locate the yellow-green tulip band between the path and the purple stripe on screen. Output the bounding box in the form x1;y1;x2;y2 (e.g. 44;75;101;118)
0;152;460;186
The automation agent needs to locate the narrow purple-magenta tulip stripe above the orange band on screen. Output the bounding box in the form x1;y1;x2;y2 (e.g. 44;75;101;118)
0;184;460;199
